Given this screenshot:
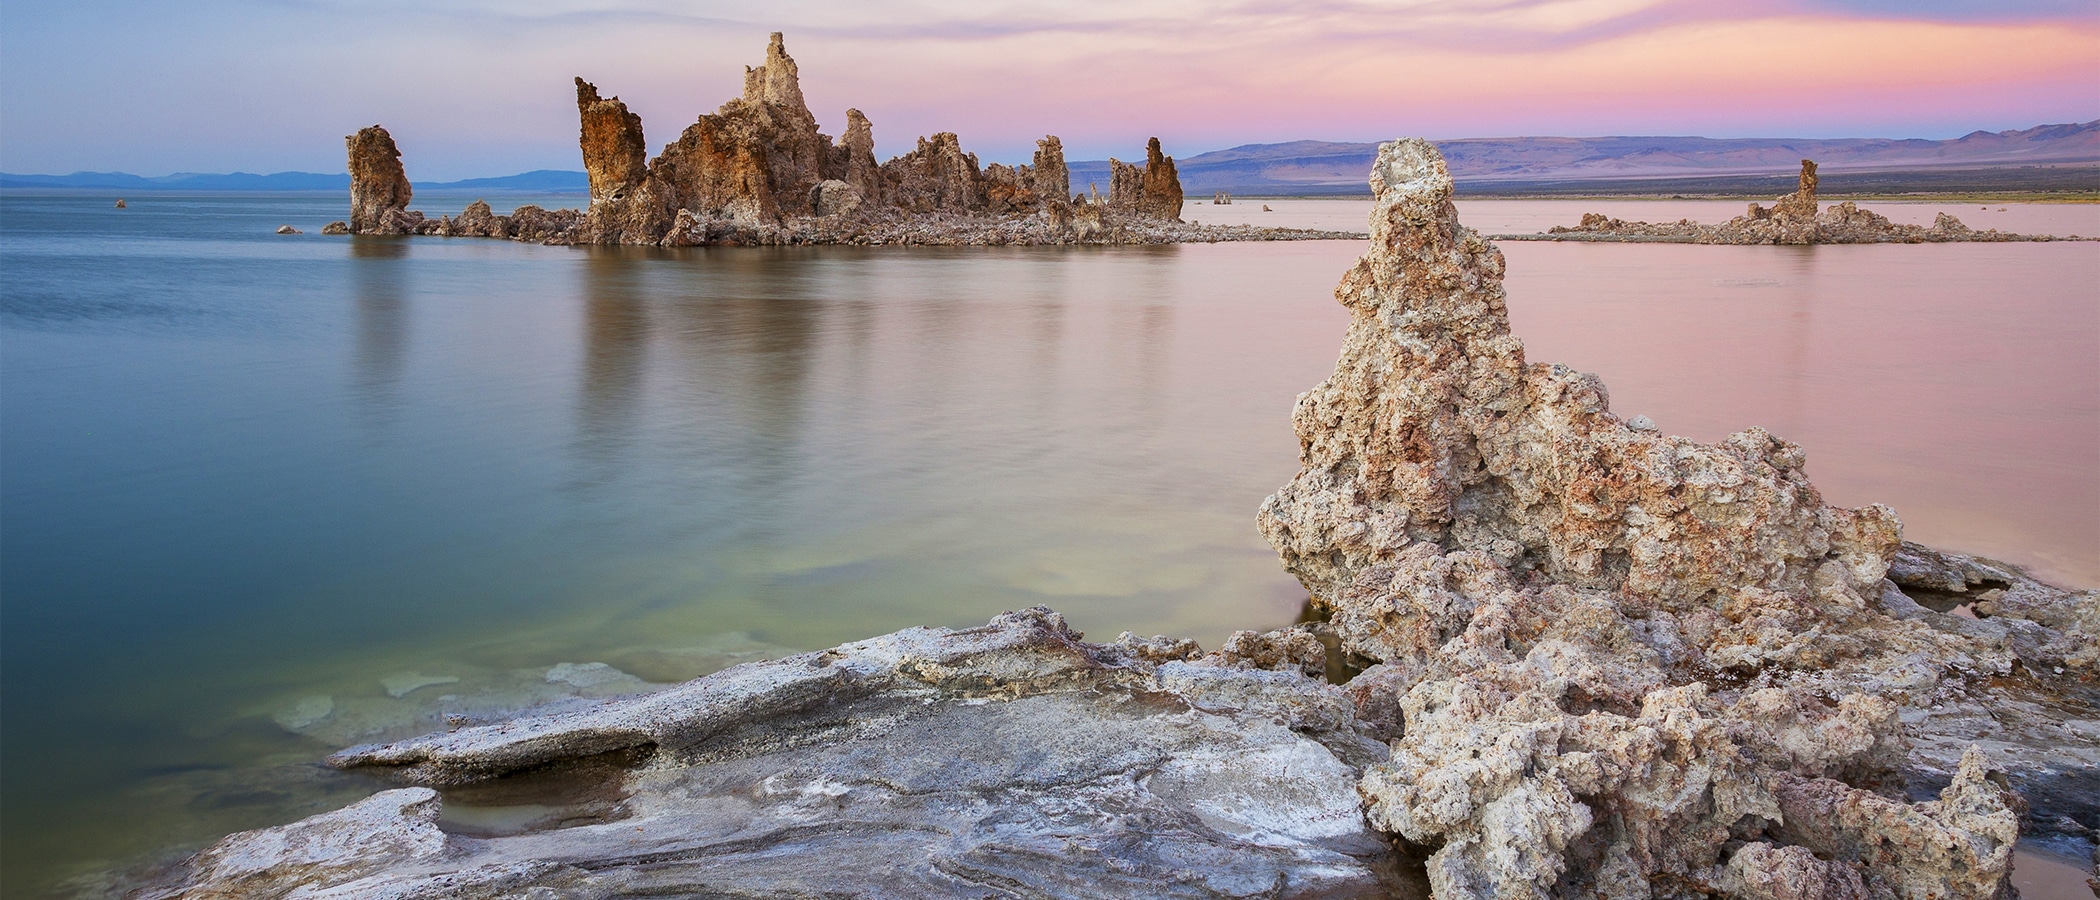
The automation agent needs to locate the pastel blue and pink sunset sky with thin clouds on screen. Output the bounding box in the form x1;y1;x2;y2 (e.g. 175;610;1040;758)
0;0;2100;180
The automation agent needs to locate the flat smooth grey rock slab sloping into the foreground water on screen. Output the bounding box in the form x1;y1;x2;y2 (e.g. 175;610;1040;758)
134;608;1411;898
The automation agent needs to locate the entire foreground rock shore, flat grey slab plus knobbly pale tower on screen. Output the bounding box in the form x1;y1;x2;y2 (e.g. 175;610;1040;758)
132;141;2100;900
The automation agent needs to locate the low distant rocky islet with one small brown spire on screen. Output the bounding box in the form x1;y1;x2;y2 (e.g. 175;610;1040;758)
1495;159;2081;243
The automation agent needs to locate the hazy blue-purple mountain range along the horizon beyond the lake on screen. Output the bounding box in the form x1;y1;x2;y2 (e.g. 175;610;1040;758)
0;120;2100;197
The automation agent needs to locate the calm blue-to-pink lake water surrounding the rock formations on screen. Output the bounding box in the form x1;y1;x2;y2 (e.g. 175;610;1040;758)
0;193;2100;896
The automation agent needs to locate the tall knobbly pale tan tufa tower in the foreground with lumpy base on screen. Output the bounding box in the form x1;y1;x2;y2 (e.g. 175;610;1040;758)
1260;141;2094;900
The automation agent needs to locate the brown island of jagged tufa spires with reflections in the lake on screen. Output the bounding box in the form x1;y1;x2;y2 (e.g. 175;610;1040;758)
323;34;1363;248
